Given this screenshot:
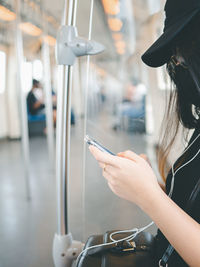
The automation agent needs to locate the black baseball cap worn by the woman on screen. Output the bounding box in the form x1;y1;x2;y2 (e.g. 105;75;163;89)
142;0;200;67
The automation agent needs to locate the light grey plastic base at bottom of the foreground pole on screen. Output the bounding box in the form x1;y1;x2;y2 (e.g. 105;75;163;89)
53;233;84;267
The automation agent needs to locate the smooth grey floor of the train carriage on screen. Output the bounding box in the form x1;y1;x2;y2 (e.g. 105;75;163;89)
0;116;156;267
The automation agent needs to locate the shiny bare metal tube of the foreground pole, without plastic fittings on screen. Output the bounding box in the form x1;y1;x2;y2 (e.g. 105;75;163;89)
56;0;77;235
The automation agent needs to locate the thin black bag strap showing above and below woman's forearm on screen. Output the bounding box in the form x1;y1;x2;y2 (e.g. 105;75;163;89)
159;179;200;267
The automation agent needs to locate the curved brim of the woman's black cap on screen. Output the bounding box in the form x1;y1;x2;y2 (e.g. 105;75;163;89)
142;9;200;68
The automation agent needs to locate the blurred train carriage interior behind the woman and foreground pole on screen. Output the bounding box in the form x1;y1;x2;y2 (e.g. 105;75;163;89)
0;0;186;267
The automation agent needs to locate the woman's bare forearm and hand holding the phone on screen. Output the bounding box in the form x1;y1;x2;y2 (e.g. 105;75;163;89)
90;146;200;267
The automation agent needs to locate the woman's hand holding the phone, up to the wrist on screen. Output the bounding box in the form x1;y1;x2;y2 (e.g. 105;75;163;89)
90;146;160;208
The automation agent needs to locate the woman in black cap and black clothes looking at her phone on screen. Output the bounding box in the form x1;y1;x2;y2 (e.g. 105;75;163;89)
90;0;200;267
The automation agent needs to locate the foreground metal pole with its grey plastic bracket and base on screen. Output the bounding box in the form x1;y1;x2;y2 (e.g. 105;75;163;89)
53;0;104;267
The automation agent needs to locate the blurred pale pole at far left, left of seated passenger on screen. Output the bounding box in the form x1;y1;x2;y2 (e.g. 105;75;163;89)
16;0;31;200
